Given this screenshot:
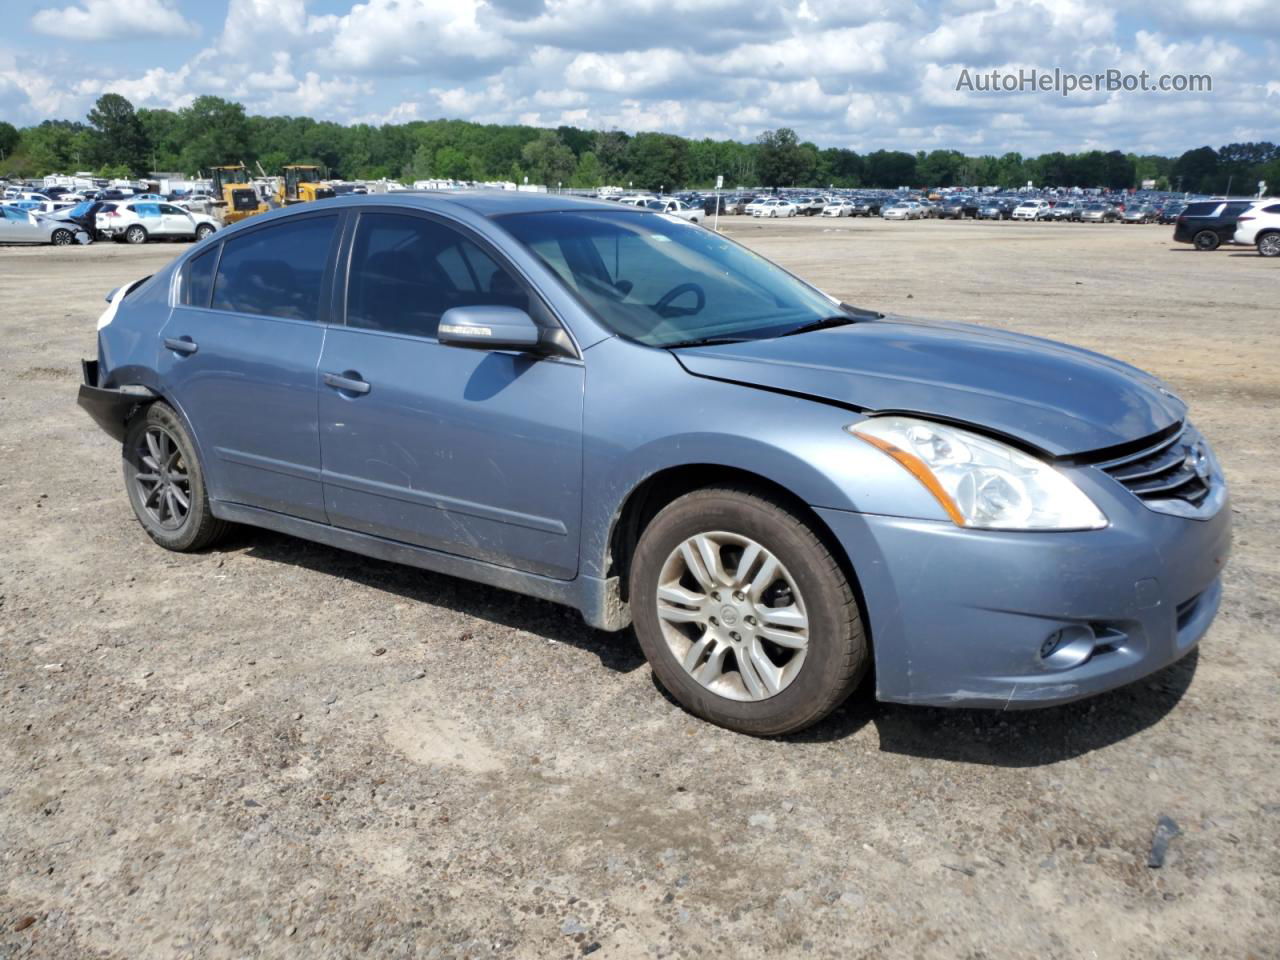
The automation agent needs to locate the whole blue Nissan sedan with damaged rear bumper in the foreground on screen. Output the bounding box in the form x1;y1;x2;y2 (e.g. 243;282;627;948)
79;192;1230;735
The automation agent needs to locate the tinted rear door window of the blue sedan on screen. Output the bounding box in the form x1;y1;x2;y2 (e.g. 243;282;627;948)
212;216;338;320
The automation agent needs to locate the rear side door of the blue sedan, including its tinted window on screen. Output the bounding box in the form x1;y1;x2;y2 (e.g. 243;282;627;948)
160;214;339;522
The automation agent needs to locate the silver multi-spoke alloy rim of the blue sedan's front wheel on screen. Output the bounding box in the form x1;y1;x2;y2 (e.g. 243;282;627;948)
655;531;809;701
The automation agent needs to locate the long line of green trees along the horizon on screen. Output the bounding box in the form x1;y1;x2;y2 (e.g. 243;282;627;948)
0;93;1280;195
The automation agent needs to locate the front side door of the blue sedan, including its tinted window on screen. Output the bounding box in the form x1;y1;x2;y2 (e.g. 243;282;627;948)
320;211;584;579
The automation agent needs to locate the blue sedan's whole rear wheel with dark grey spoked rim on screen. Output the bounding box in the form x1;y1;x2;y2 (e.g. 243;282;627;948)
123;402;227;553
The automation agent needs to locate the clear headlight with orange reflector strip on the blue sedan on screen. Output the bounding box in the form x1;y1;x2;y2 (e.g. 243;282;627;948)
846;416;1107;530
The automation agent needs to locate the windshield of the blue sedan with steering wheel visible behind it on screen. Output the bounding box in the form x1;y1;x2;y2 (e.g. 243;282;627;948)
498;210;842;347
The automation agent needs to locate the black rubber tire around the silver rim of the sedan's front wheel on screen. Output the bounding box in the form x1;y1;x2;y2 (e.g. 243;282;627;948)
630;486;870;736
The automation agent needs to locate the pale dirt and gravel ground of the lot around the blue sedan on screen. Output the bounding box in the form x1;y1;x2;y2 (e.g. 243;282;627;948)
0;218;1280;960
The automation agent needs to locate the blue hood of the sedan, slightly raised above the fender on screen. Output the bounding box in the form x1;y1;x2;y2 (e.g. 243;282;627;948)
672;317;1187;457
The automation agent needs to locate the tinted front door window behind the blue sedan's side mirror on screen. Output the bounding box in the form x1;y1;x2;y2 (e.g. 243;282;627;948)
347;214;538;337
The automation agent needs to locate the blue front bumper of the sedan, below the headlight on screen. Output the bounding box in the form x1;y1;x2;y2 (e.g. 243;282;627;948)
818;483;1231;709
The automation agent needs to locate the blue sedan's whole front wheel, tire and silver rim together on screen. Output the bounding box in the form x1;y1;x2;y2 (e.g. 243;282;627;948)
630;488;870;736
